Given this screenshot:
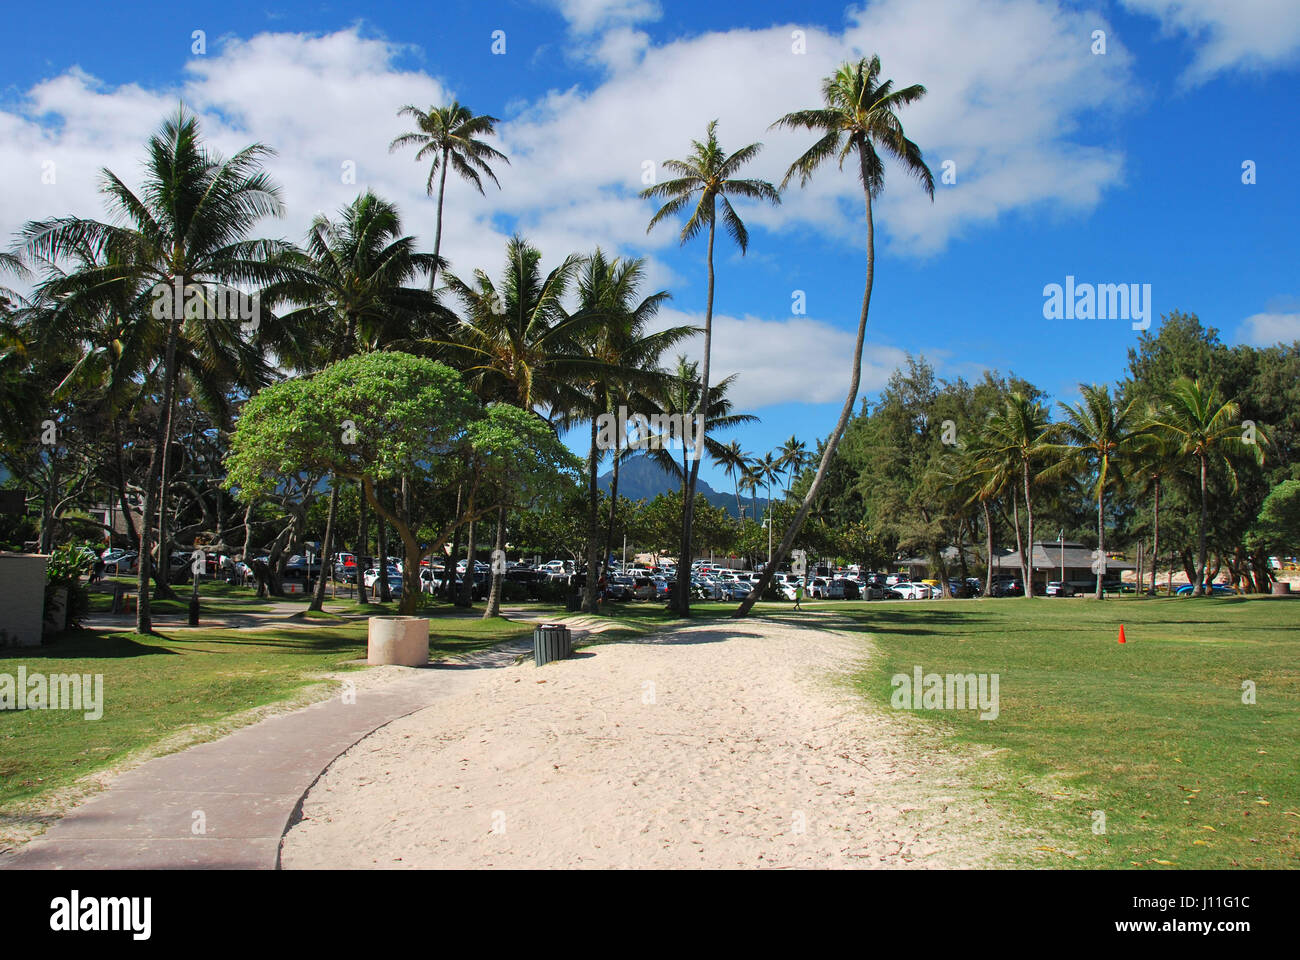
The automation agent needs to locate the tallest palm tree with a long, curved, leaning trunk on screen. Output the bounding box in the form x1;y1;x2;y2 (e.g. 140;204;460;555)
736;56;935;617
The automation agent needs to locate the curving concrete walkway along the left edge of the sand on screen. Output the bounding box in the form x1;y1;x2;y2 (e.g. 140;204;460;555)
0;628;586;870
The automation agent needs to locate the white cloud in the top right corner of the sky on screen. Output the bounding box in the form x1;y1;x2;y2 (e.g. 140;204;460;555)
1121;0;1300;83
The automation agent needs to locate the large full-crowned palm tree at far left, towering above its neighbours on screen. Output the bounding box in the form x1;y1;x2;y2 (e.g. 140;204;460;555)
22;107;285;633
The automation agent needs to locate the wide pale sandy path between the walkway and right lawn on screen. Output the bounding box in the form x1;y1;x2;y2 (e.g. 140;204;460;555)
282;620;1006;869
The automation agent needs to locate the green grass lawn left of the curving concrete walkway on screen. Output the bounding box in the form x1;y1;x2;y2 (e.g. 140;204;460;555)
0;609;532;806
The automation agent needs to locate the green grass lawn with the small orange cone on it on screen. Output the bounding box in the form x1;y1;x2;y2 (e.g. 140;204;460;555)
827;597;1300;869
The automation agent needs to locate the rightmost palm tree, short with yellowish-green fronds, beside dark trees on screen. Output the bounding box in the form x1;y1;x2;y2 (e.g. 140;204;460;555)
1147;377;1266;597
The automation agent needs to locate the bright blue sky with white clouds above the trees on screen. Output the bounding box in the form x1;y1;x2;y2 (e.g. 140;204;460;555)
0;0;1300;489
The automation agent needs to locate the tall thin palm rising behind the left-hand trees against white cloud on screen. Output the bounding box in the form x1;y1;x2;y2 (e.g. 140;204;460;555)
389;100;510;293
